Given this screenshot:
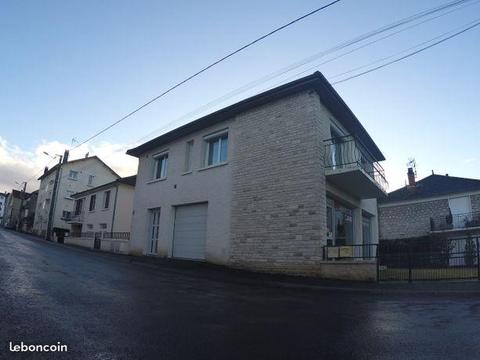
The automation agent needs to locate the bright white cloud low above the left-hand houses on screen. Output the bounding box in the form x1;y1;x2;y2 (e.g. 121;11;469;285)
0;137;137;192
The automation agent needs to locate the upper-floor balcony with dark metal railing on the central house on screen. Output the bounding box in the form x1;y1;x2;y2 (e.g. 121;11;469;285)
325;135;388;199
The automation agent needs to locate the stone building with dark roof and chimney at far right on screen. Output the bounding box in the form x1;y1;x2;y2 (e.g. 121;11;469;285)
378;168;480;240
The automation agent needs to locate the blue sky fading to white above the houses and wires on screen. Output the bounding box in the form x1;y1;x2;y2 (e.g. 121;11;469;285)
0;0;480;192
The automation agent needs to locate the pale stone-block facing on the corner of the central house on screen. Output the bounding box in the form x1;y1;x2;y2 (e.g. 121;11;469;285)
230;91;329;275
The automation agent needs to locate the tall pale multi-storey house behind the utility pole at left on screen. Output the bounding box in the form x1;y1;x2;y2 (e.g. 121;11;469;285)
33;151;120;242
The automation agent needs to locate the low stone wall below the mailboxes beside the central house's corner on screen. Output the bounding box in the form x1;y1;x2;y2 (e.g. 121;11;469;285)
320;261;377;281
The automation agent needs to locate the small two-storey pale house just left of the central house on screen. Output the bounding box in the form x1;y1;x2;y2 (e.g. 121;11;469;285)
65;175;136;253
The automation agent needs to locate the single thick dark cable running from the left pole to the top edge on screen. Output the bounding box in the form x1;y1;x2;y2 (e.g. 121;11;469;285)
72;0;341;150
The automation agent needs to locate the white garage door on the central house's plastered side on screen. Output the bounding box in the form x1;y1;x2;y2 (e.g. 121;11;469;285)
173;204;207;260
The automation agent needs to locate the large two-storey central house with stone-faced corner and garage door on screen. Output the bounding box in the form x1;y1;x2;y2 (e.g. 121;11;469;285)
127;72;386;277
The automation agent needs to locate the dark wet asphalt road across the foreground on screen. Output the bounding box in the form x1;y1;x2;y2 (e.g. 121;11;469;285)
0;230;480;360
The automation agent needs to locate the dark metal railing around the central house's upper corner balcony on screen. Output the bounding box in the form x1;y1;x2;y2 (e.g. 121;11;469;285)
325;135;388;192
